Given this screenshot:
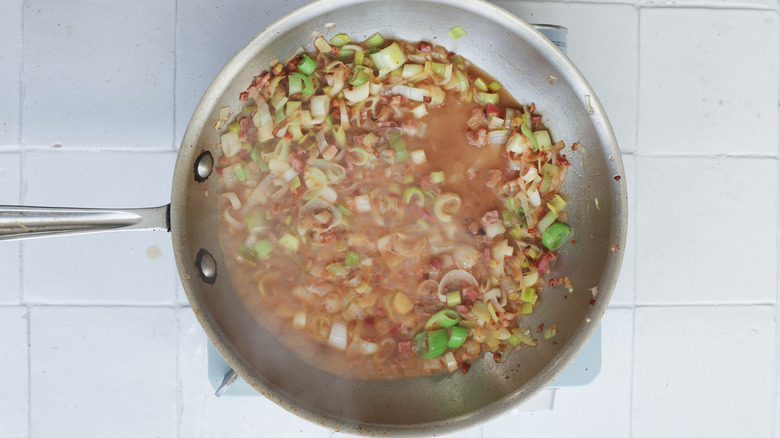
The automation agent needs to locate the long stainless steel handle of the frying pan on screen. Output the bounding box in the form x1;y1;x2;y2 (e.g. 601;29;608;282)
0;204;171;240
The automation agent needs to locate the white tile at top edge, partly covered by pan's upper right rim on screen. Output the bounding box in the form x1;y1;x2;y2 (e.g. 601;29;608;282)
493;0;639;152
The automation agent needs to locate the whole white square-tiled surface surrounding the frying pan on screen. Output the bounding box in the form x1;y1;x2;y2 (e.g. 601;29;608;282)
0;0;780;438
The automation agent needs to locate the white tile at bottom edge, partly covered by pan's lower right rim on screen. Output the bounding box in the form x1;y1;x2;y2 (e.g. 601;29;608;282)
483;309;633;438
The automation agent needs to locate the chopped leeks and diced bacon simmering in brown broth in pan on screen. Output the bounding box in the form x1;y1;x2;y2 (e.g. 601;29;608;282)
218;34;571;379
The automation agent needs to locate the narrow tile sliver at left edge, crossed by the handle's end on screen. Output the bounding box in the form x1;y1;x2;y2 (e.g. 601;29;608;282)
0;152;21;304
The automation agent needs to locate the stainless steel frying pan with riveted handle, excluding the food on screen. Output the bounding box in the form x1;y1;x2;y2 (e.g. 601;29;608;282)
0;0;626;434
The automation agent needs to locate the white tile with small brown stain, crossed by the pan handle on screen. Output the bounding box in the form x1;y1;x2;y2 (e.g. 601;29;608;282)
22;151;179;304
